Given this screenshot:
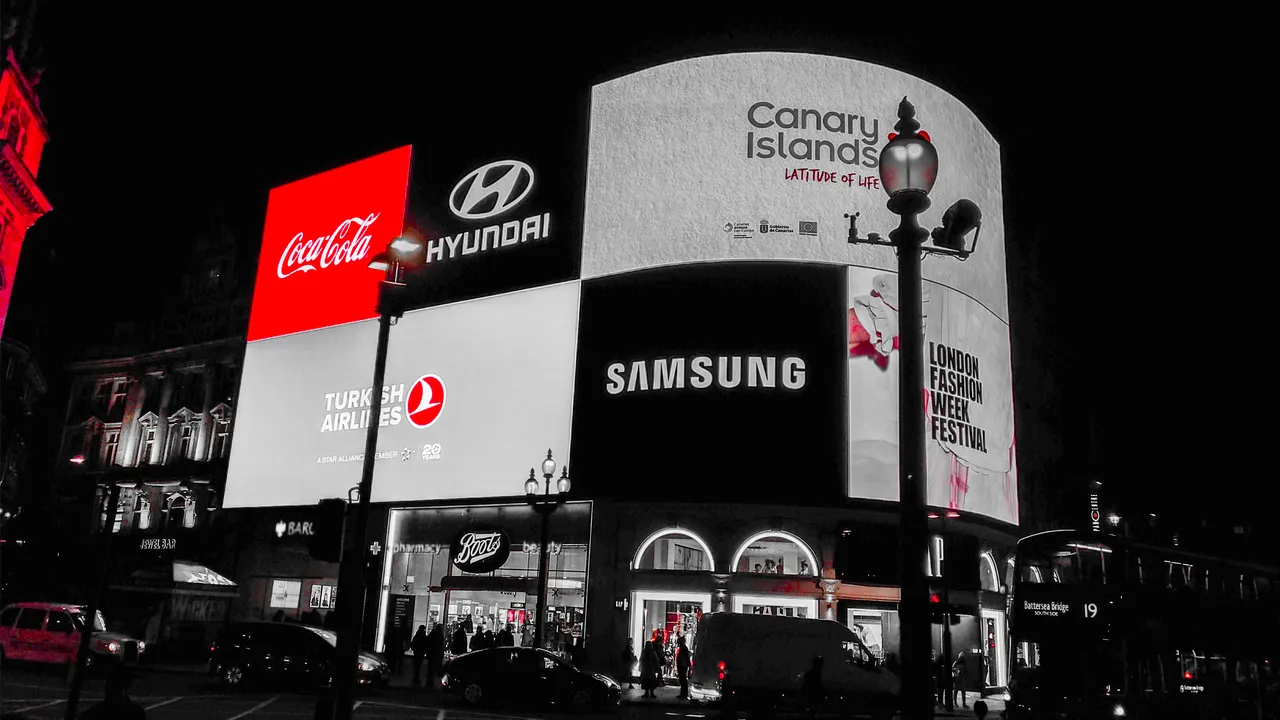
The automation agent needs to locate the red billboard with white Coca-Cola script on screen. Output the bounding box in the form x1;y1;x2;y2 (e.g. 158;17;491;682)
248;146;410;341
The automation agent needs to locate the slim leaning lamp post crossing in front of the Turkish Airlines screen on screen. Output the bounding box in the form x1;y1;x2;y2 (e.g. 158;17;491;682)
333;237;422;720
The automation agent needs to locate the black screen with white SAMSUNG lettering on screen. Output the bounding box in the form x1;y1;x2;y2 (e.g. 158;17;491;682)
573;263;846;503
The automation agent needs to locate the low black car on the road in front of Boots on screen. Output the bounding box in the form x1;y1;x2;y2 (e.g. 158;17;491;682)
440;647;622;710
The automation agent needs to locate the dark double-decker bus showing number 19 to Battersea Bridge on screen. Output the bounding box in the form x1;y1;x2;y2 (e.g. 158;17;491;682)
1006;530;1280;720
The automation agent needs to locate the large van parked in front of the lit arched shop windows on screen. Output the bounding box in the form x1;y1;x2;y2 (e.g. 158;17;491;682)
689;612;900;717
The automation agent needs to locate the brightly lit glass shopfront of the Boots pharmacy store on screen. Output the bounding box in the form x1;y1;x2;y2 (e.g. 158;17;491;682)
376;502;591;652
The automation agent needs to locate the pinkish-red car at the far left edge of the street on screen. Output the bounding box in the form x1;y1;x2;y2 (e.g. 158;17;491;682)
0;602;146;666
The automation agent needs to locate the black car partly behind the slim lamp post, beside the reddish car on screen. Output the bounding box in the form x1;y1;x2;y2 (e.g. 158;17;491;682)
209;623;390;687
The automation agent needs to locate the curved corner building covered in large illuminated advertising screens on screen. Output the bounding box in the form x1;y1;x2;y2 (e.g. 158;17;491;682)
217;53;1021;687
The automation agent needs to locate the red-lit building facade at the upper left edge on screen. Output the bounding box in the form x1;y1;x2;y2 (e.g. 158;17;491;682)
0;51;50;333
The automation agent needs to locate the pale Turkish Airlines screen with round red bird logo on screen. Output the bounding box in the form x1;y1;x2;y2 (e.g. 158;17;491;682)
224;283;579;507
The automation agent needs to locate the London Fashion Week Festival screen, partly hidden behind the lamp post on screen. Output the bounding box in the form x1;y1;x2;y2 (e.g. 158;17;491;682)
847;268;1018;523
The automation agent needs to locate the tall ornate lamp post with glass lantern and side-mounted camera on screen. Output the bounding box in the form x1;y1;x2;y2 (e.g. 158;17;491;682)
849;97;982;720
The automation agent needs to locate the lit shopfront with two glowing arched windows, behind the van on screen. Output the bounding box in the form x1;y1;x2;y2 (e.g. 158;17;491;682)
630;528;819;678
